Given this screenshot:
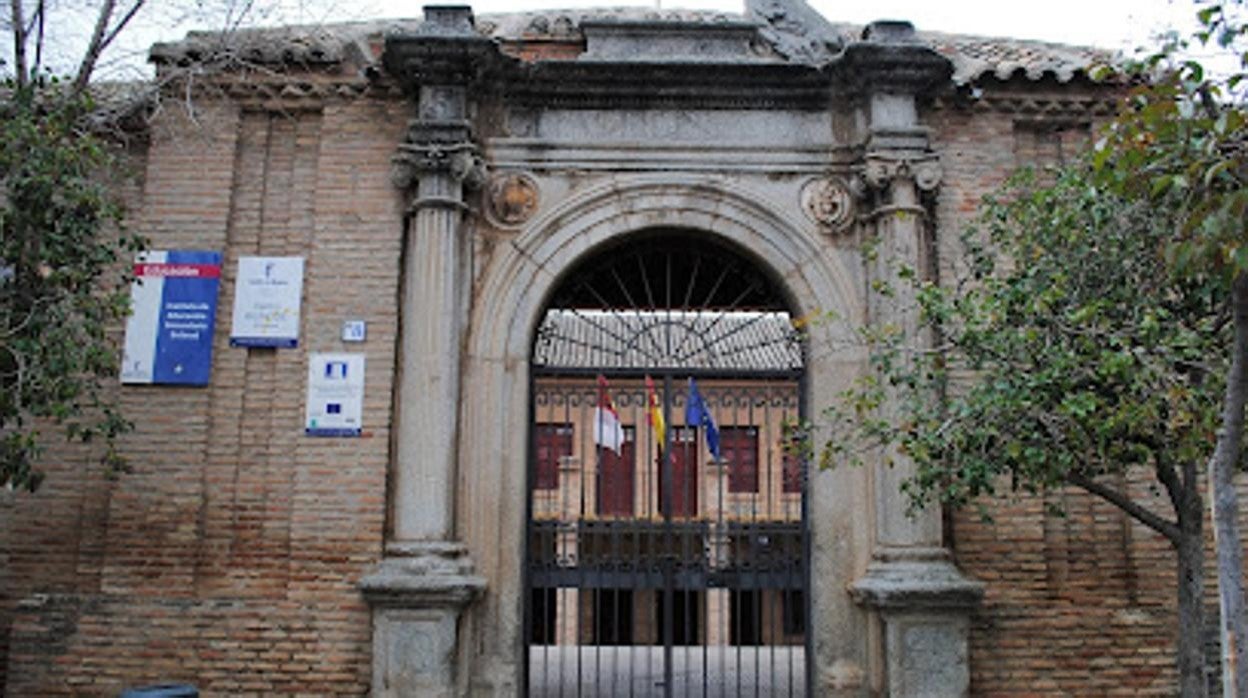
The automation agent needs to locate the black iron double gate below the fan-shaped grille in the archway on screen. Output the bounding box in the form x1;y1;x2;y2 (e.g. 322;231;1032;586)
523;370;811;698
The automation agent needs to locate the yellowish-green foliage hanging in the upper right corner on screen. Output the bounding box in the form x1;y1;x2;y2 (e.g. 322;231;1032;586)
1093;2;1248;276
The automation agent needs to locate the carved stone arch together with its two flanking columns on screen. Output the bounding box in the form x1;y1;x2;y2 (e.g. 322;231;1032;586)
361;7;982;696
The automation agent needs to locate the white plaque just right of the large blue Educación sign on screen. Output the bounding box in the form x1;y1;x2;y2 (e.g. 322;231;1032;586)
230;257;303;347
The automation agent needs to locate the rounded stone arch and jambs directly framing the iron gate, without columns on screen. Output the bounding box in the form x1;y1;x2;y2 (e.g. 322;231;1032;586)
456;176;874;694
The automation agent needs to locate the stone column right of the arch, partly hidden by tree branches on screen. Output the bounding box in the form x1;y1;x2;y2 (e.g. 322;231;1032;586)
850;22;983;698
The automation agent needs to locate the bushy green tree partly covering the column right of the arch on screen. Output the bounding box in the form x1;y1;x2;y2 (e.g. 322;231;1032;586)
824;164;1232;697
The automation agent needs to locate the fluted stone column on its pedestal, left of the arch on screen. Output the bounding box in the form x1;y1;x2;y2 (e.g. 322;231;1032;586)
359;7;485;698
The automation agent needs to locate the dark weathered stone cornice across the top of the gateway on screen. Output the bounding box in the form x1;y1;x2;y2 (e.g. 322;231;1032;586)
382;15;952;110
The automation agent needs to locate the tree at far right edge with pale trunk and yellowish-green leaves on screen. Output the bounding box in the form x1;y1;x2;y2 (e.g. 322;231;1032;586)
1096;2;1248;698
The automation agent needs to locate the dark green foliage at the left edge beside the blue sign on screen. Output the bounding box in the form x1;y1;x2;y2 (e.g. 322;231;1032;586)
0;81;144;491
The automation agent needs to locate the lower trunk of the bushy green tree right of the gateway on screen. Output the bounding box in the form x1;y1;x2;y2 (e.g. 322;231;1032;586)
1174;506;1207;698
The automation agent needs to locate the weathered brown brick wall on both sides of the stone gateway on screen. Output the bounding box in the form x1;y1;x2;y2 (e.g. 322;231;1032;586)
0;68;1248;696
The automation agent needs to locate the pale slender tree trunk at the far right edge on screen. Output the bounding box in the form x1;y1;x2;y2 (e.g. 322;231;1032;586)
1209;272;1248;698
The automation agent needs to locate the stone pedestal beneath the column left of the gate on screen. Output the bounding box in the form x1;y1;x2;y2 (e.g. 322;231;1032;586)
359;542;485;698
